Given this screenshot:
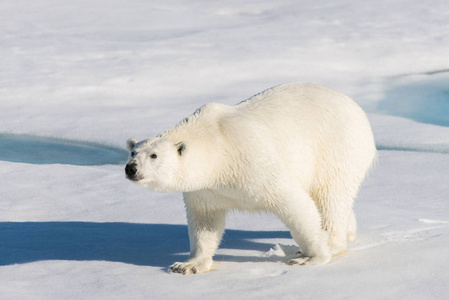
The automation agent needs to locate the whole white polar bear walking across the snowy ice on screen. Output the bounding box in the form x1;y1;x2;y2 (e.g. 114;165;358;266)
125;83;377;274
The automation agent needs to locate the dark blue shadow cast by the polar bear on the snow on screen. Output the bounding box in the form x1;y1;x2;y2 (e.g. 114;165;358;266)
0;222;291;268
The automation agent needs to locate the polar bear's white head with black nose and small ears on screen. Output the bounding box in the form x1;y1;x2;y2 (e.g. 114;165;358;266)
125;137;187;192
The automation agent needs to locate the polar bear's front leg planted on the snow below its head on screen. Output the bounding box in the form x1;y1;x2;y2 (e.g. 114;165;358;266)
170;193;226;274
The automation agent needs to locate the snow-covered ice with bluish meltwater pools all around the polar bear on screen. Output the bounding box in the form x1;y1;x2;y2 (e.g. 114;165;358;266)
0;0;449;299
